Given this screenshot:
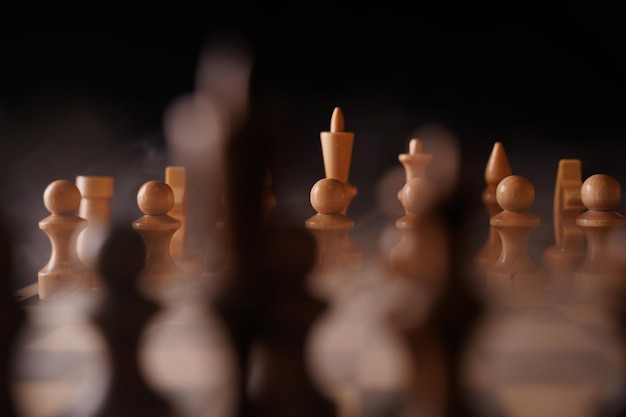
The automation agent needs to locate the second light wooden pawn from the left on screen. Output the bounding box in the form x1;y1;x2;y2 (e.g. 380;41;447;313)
133;180;181;299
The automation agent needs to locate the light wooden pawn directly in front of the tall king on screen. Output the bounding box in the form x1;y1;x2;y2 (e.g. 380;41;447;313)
305;178;361;282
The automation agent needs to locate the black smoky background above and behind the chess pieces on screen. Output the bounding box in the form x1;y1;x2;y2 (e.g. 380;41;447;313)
0;0;626;283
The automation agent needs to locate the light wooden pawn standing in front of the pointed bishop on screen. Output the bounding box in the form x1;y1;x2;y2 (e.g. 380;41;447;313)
486;175;543;303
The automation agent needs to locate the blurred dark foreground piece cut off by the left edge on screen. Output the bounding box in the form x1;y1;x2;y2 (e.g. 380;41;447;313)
0;223;26;417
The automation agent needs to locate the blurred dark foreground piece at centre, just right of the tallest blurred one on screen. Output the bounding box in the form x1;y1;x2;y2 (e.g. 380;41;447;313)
249;223;335;417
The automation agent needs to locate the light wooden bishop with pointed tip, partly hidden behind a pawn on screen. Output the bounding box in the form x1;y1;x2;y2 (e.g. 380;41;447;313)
475;142;512;280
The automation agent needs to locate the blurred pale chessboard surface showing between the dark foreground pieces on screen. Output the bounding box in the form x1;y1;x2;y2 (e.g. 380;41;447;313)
14;256;623;417
